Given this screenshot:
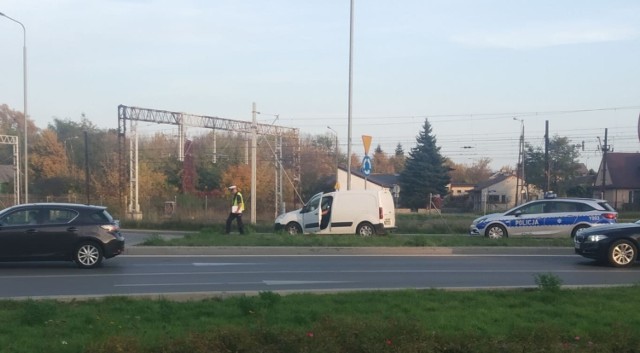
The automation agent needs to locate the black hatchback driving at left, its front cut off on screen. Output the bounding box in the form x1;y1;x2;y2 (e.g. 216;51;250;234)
0;203;124;268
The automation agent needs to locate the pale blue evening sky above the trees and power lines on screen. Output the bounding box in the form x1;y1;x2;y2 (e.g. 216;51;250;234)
0;0;640;172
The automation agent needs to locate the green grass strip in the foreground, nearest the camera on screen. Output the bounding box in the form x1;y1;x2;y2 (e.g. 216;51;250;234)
0;286;640;353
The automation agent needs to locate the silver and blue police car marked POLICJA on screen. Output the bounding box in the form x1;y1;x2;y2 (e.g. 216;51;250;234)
469;198;618;239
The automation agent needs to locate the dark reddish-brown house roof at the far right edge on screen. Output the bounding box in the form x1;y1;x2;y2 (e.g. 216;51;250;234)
595;152;640;189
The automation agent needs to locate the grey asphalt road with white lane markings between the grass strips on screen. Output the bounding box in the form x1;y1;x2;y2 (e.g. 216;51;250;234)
0;247;640;299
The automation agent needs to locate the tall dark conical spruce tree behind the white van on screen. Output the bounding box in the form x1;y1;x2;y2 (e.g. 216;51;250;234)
399;119;450;210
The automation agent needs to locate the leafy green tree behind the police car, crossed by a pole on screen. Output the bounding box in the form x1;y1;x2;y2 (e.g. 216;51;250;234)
524;135;580;196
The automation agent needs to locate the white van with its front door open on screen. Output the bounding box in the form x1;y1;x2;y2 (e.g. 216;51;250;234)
275;190;396;236
